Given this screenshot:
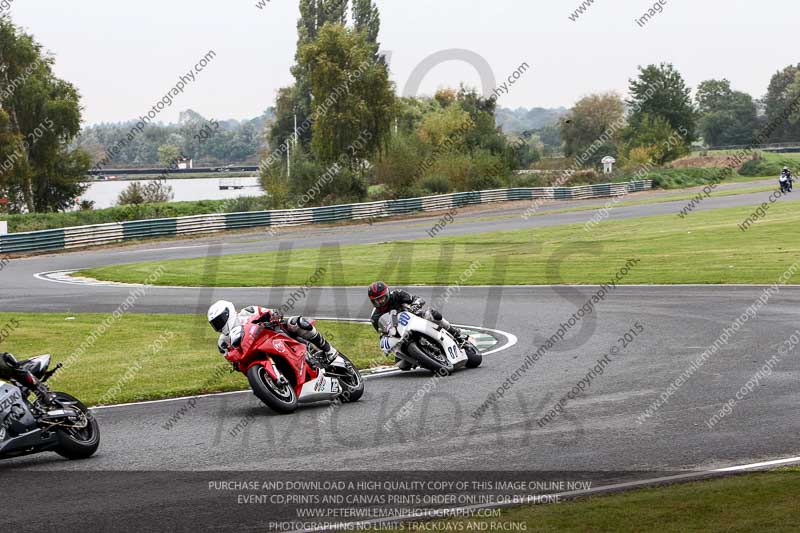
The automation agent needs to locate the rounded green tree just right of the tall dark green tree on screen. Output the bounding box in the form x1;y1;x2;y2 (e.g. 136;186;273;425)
695;79;758;146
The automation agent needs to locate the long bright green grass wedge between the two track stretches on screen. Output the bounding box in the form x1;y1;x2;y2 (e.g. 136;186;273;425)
81;196;800;287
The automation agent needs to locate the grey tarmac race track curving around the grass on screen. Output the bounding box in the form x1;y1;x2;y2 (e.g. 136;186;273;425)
0;185;800;531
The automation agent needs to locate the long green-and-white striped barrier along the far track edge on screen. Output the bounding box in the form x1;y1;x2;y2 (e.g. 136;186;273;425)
0;180;652;254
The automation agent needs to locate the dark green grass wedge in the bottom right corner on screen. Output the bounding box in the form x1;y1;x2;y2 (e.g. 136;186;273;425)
428;468;800;533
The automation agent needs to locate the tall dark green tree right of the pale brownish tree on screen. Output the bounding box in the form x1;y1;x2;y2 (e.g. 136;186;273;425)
627;63;697;146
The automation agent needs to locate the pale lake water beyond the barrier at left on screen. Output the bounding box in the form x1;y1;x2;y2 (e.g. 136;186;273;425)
81;176;264;209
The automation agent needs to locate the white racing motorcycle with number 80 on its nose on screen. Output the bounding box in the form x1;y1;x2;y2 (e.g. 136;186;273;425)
378;310;483;374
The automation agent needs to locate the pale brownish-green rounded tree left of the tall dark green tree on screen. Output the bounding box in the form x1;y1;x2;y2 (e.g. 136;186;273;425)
561;93;625;165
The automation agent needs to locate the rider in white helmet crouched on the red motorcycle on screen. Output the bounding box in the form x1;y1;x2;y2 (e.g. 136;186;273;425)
208;300;339;367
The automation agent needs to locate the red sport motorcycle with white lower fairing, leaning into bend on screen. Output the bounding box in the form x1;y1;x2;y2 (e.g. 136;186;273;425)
225;317;364;414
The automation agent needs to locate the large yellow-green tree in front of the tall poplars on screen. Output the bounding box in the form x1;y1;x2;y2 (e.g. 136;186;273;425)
300;24;395;168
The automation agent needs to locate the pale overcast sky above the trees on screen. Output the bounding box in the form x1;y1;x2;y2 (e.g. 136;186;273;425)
9;0;800;124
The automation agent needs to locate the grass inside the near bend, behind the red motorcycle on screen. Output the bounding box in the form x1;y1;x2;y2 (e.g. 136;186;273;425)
0;313;387;405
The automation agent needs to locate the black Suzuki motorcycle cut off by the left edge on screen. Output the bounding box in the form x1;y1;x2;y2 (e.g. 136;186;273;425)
0;353;100;459
